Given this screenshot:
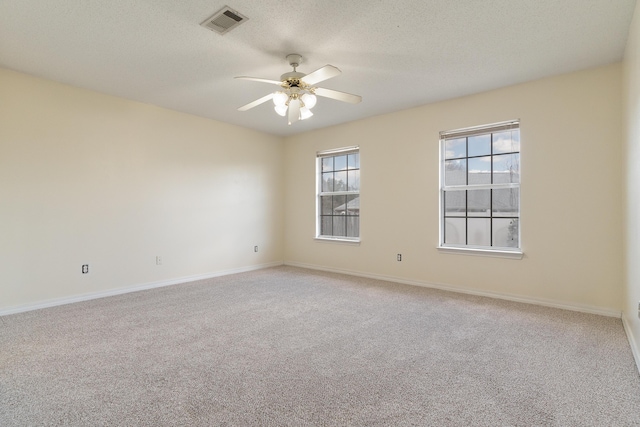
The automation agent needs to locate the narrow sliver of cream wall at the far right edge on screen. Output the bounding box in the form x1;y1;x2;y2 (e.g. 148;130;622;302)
623;0;640;369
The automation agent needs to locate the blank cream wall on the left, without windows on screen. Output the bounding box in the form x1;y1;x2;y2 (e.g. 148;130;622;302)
0;69;284;312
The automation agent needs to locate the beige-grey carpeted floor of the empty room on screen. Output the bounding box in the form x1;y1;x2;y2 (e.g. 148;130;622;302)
0;267;640;426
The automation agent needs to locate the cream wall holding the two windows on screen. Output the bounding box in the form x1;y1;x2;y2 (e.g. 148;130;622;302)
285;64;623;314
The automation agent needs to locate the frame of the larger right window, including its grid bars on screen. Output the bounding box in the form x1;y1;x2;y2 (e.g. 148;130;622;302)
438;119;524;259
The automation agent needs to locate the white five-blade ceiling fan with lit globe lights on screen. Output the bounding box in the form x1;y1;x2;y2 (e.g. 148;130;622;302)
236;53;362;124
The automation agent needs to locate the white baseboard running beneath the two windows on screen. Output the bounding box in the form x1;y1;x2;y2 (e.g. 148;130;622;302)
284;261;622;318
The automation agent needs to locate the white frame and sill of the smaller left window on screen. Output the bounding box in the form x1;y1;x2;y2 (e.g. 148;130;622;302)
315;146;361;244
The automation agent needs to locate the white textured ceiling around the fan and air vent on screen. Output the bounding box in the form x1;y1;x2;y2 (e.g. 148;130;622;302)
0;0;636;136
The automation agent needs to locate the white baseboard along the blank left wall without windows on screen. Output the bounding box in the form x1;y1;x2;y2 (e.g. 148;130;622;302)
0;262;283;316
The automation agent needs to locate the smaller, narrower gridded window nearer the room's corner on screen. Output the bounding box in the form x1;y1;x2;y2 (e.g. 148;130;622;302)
316;147;360;241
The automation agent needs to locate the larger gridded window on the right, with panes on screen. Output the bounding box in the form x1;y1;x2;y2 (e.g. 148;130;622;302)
440;121;520;253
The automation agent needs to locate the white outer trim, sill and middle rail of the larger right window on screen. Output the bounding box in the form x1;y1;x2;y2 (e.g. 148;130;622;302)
436;119;524;259
